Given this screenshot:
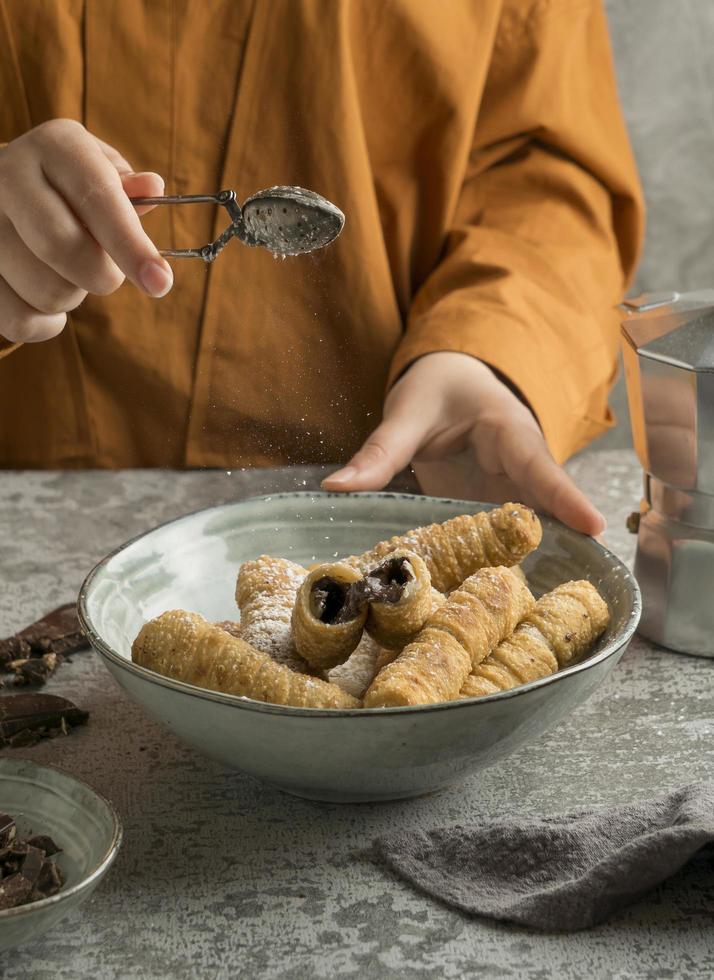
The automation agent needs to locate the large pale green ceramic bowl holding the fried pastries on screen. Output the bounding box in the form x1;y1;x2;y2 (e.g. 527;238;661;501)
79;493;640;802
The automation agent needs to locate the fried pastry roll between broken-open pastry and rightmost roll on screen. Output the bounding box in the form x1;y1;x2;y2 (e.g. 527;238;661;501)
364;567;535;708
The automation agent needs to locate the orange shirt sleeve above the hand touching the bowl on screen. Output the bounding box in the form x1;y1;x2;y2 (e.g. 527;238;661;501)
391;0;644;461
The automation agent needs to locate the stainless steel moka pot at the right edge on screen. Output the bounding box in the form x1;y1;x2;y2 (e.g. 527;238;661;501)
622;290;714;657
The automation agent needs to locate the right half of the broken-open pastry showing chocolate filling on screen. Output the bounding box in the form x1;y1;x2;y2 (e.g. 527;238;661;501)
364;548;432;650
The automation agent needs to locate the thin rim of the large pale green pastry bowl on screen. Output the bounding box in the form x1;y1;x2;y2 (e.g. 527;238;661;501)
77;490;642;718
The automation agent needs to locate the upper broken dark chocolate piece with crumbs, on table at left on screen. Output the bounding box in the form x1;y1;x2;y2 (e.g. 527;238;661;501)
0;602;88;686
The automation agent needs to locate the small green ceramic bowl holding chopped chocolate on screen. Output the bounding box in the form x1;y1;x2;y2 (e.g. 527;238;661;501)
0;758;122;950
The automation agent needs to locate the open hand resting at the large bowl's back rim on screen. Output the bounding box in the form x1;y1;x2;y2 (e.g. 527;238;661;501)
323;351;605;535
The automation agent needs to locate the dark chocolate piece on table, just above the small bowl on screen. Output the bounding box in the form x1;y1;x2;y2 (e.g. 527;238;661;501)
0;694;89;748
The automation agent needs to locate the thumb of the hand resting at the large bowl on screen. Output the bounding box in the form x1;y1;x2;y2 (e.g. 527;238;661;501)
322;411;426;490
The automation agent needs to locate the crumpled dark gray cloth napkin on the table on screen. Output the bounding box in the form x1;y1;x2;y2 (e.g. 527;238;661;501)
375;783;714;931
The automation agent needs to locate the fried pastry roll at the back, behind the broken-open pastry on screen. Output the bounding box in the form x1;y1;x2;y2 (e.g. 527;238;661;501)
346;504;542;592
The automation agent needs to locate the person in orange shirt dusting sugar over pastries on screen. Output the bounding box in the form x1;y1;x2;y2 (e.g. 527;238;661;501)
0;0;643;534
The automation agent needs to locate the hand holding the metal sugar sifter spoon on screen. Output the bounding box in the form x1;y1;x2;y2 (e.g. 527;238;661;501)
0;119;173;342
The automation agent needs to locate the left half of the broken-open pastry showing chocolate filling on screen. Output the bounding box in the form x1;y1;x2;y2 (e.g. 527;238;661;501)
292;562;367;670
